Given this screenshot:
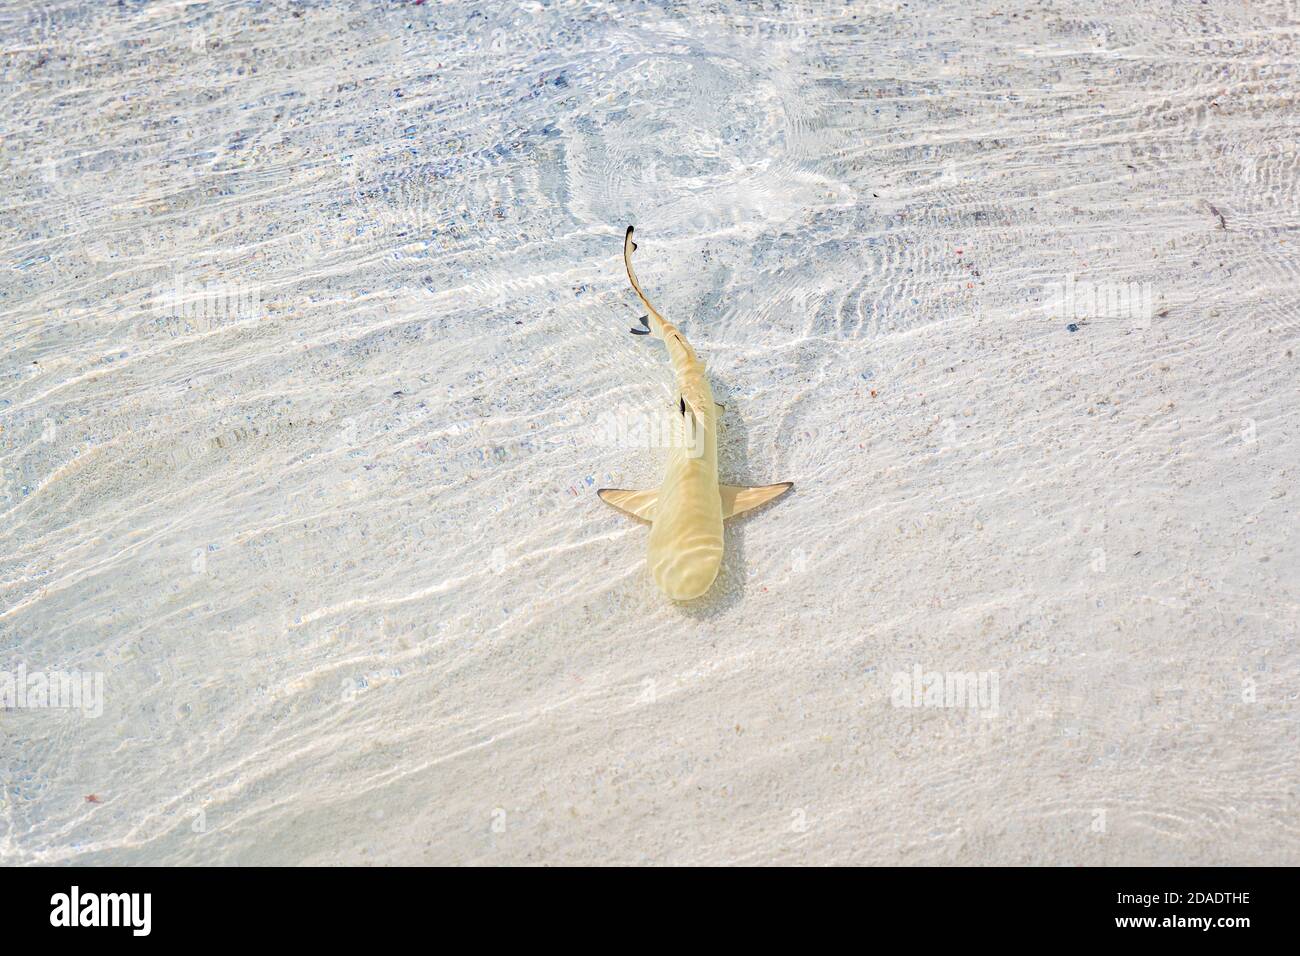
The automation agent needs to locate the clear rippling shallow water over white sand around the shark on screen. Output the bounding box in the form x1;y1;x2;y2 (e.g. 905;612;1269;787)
0;0;1300;864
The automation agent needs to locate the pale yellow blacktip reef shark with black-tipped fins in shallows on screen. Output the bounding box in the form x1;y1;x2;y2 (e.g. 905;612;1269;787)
597;226;793;601
